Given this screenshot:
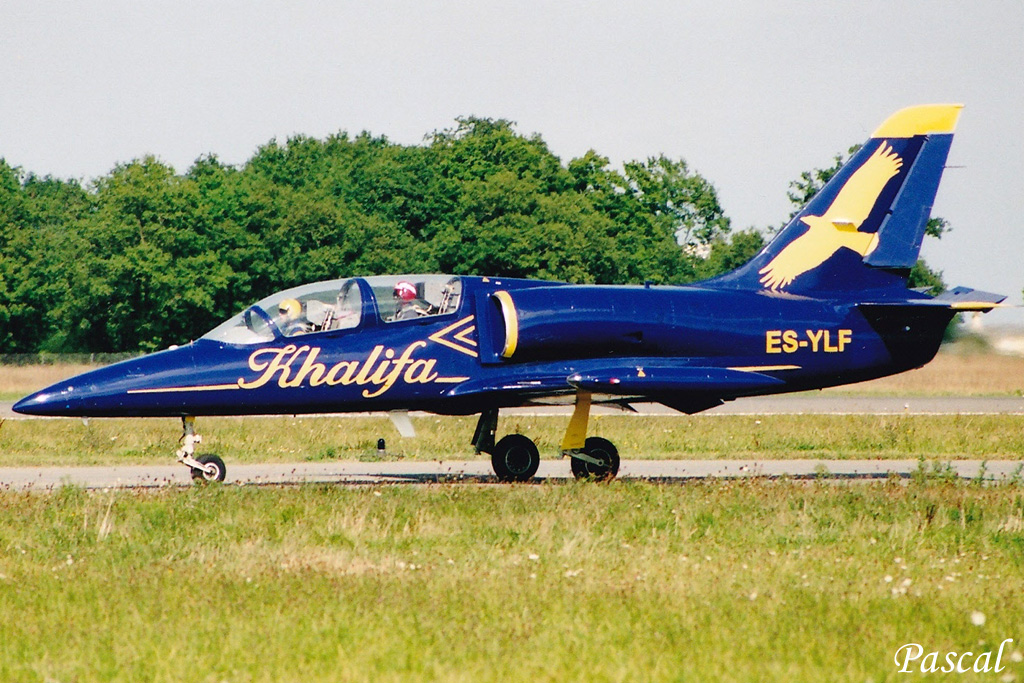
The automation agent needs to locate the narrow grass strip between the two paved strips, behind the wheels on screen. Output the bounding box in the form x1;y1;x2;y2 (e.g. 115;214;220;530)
0;415;1024;467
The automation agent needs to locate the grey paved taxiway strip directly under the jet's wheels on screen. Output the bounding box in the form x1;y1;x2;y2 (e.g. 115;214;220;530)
0;459;1024;490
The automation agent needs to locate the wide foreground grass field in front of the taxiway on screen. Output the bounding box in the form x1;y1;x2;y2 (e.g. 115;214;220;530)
0;481;1024;683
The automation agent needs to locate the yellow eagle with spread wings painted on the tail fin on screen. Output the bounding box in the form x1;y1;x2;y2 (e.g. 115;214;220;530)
758;143;903;290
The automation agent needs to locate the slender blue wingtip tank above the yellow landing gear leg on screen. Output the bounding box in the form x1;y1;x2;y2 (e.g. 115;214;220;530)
568;366;782;395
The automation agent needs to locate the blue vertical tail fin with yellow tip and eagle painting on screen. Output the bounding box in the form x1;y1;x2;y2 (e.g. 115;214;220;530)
709;104;963;294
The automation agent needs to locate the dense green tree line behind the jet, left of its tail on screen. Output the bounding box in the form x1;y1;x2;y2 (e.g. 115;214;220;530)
0;118;942;353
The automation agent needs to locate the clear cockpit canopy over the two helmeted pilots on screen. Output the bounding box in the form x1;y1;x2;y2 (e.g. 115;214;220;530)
203;275;462;344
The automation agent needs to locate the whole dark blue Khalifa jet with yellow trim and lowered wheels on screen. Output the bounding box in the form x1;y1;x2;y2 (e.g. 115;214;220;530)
14;104;1004;481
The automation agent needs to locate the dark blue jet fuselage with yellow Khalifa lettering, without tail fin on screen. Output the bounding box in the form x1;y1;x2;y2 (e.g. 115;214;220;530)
14;276;951;417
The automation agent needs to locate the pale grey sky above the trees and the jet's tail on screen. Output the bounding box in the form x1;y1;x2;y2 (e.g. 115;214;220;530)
6;0;1024;325
